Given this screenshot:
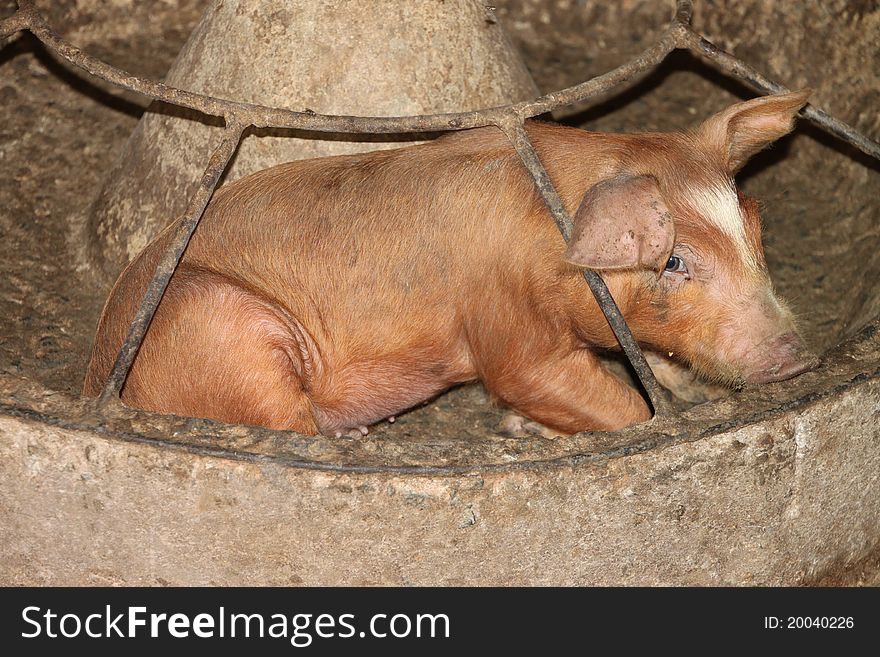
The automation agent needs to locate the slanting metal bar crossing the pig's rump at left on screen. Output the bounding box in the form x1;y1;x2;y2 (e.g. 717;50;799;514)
98;120;247;407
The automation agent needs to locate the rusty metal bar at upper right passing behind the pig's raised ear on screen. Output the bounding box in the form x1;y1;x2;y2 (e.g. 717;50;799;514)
676;28;880;160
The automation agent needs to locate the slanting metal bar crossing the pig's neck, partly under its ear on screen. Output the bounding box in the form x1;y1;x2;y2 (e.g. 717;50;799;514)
498;115;675;419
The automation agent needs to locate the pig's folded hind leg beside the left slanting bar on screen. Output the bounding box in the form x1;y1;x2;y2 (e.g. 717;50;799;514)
122;269;318;434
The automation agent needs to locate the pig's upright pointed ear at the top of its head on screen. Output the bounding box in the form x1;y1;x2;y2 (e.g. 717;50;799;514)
697;89;812;175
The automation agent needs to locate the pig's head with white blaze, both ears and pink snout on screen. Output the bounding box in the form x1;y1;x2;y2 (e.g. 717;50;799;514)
566;90;815;384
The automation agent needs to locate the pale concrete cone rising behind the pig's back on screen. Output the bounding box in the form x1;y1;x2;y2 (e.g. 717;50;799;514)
85;0;537;279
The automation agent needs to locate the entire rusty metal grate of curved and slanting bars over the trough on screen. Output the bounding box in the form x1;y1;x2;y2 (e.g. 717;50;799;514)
0;0;880;433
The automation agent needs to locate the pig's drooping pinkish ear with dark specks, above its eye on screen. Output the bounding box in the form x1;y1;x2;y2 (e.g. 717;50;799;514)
564;175;675;271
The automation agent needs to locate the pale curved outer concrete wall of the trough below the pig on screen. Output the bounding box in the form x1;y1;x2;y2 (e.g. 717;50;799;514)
0;379;880;585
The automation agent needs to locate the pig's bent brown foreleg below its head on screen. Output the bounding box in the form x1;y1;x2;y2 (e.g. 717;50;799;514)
483;349;651;435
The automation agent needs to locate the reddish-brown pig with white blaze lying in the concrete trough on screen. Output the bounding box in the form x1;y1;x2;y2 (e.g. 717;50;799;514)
84;90;815;436
